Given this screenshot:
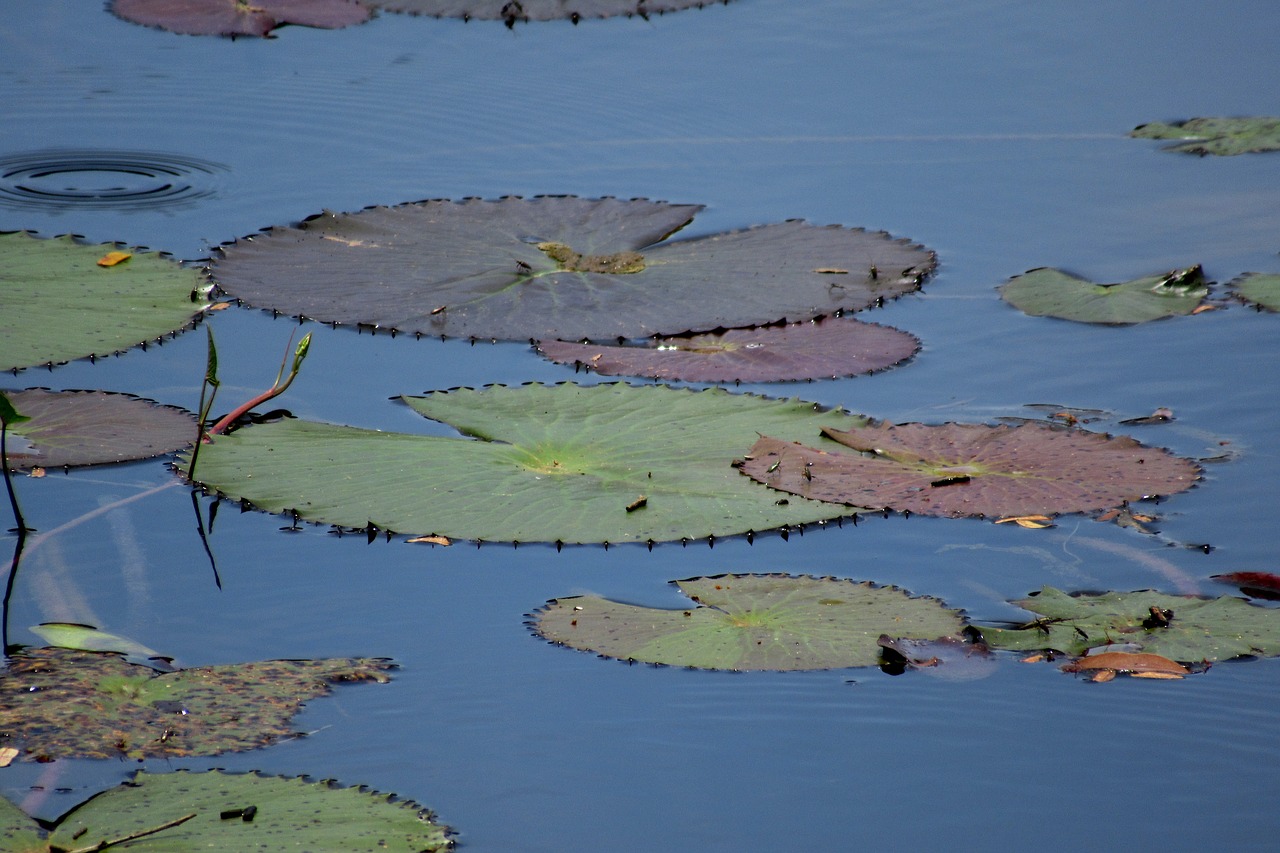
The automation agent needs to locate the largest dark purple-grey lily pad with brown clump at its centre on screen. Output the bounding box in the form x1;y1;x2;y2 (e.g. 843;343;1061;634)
210;196;936;341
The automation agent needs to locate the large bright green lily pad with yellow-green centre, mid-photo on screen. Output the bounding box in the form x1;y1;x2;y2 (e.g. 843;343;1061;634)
183;384;864;543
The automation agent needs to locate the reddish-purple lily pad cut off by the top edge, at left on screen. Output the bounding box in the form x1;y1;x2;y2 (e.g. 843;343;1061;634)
110;0;372;36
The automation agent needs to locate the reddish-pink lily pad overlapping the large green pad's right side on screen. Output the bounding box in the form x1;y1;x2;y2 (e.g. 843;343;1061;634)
741;423;1199;517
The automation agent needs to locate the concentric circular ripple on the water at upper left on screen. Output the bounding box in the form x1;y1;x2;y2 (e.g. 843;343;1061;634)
0;149;227;210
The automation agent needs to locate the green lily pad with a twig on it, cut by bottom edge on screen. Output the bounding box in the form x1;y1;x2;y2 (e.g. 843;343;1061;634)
0;770;452;853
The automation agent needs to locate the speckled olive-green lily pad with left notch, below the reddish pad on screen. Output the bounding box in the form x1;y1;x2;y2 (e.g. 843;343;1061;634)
531;574;965;671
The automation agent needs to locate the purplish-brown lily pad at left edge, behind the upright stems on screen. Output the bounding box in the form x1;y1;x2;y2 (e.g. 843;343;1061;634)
5;388;196;470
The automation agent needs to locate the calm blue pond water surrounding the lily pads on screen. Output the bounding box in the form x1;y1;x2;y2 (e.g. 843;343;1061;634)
0;0;1280;853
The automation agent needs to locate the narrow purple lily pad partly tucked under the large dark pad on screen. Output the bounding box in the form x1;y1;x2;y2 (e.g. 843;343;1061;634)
538;318;920;382
